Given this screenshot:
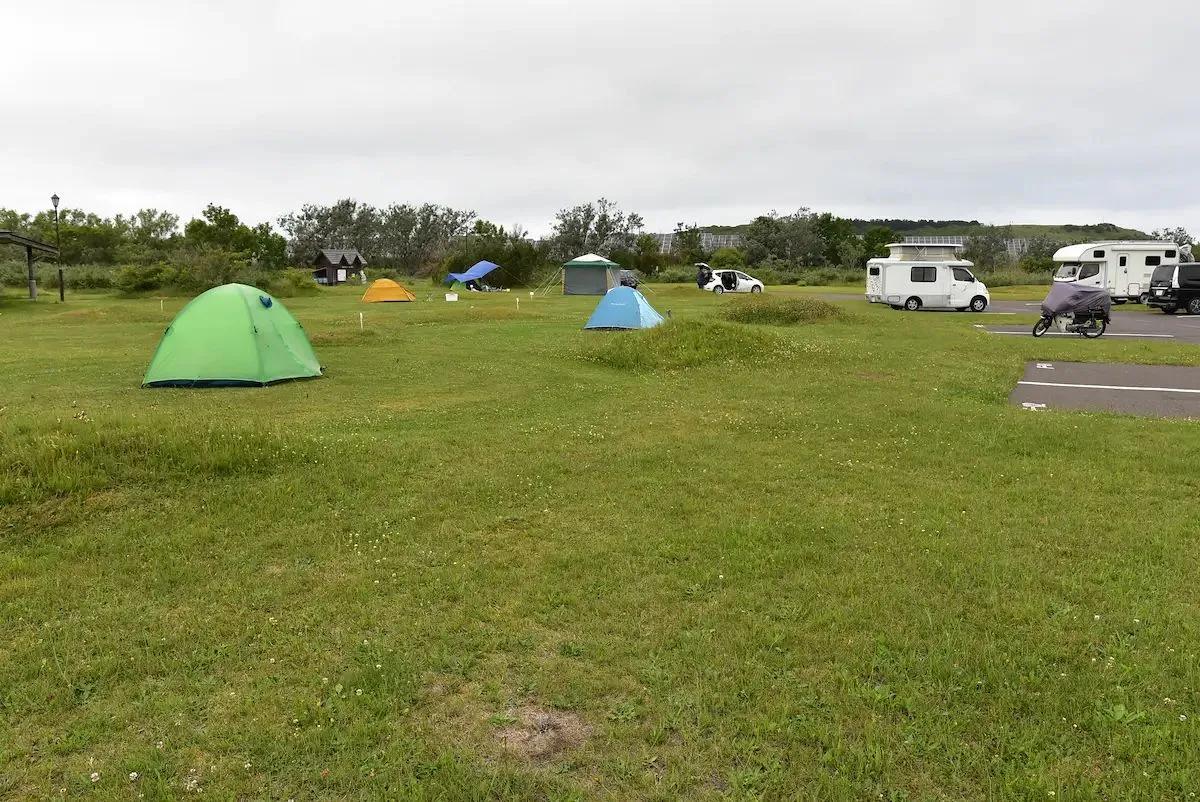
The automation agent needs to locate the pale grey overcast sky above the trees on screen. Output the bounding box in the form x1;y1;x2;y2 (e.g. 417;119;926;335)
0;0;1200;234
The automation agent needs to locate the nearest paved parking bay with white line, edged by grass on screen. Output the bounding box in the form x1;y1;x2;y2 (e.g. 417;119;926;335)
1008;360;1200;418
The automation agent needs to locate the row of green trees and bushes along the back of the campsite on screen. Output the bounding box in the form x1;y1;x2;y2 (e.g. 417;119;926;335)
0;198;1192;291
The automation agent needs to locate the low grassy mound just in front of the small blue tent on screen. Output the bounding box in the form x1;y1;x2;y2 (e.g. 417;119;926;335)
580;321;788;371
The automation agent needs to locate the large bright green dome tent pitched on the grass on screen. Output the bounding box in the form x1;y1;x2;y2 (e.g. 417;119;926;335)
142;285;320;387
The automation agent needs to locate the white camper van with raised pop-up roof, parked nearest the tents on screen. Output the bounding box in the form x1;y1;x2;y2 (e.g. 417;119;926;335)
866;243;991;312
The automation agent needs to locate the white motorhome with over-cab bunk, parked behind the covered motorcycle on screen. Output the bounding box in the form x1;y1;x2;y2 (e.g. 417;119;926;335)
1054;240;1180;304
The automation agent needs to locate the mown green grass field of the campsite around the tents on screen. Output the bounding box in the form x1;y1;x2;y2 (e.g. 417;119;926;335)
0;287;1200;800
